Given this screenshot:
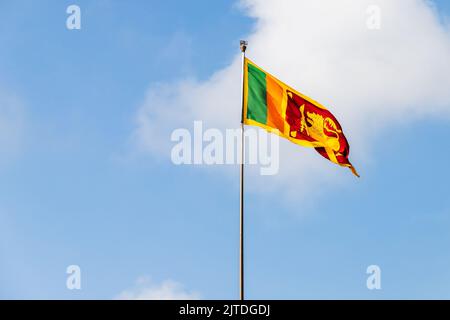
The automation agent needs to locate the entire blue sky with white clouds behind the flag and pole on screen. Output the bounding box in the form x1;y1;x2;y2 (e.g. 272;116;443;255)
0;0;450;299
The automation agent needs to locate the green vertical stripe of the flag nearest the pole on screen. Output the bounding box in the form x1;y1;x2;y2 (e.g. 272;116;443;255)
247;64;267;124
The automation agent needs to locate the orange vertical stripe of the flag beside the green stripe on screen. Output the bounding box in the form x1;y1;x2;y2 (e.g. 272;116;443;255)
266;75;284;133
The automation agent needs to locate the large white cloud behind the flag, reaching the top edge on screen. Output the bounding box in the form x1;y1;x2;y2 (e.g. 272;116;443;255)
134;0;450;195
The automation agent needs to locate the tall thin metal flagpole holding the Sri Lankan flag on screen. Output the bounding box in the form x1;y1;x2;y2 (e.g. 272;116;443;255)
239;40;248;300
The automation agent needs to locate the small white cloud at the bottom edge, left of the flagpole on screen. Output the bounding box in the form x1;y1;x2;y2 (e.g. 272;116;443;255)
117;277;200;300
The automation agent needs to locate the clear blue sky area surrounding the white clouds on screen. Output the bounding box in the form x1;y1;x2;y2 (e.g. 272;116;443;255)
0;0;450;299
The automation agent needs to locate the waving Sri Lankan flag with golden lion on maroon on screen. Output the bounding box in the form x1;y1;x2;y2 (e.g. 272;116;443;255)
243;59;359;177
